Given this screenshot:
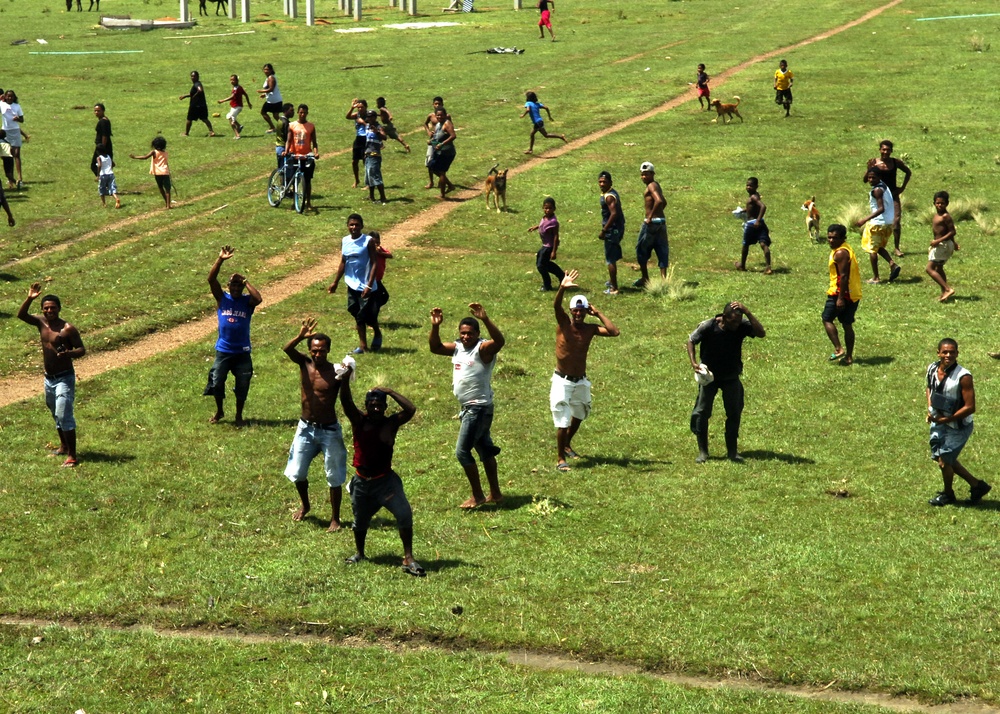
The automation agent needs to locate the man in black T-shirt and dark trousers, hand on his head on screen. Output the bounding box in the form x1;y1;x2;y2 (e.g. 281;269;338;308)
687;300;765;464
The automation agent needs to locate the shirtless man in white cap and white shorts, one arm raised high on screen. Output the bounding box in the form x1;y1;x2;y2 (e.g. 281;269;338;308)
549;270;621;471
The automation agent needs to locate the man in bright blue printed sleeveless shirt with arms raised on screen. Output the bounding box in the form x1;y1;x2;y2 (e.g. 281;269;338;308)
202;245;262;427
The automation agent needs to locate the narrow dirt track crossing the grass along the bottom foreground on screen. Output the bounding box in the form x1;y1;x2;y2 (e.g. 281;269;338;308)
0;617;1000;714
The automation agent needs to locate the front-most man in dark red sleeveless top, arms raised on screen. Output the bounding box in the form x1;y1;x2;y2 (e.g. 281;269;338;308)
340;372;426;577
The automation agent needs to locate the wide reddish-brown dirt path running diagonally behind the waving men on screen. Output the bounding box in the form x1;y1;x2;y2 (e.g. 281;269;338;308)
0;0;903;408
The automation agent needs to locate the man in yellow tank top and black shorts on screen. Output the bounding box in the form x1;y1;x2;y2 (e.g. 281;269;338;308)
823;223;861;365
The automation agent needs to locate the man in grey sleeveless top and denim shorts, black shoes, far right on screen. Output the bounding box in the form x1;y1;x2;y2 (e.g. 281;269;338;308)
927;337;993;506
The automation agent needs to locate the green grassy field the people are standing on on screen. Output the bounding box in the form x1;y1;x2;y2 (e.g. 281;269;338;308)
0;0;1000;712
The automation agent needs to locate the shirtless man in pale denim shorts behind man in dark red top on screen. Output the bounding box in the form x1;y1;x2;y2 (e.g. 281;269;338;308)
285;319;347;533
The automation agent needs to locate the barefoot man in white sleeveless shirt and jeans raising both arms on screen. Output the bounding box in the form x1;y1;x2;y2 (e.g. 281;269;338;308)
430;302;506;508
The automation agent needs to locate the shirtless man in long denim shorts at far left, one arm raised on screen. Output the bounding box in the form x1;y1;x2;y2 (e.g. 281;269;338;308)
17;283;87;468
